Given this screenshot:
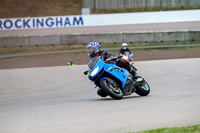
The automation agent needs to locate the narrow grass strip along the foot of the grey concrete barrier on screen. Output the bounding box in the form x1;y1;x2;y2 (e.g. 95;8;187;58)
0;41;200;55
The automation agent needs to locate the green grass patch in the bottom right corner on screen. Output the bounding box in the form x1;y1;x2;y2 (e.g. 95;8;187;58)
132;124;200;133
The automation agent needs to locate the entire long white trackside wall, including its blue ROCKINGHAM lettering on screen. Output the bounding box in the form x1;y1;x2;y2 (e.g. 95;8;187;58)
0;10;200;30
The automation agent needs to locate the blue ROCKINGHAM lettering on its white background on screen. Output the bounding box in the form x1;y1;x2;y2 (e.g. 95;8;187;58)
0;16;84;30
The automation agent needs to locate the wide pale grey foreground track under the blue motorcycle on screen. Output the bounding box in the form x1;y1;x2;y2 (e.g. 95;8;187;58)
0;58;200;133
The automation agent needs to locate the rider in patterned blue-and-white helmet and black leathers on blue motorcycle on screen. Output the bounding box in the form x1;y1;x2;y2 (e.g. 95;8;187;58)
84;42;138;97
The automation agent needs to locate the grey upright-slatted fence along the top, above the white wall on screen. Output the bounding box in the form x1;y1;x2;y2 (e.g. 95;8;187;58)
82;0;200;9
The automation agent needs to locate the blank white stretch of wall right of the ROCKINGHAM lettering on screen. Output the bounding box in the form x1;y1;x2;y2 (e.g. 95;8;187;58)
84;10;200;26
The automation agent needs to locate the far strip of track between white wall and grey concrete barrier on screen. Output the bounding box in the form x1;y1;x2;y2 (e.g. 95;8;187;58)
0;21;200;37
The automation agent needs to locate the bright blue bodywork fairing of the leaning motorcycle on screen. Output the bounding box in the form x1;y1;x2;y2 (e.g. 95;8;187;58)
88;59;130;88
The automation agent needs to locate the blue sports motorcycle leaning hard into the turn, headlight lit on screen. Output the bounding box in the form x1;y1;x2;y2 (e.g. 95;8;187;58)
84;52;150;100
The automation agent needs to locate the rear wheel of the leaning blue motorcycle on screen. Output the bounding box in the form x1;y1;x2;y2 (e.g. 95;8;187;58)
135;80;150;96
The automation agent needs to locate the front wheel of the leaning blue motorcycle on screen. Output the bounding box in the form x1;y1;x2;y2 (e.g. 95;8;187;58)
100;79;123;100
